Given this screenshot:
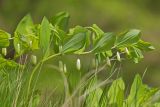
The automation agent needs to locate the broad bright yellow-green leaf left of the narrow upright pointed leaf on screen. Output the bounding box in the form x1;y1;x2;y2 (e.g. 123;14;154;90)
14;15;38;55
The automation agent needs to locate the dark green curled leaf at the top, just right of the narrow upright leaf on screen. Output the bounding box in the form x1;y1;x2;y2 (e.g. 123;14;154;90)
51;12;70;31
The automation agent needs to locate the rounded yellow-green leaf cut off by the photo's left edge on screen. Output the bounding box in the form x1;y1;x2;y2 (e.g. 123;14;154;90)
0;30;11;48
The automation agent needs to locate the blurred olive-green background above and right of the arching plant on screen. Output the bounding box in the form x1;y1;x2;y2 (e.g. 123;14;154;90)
0;0;160;86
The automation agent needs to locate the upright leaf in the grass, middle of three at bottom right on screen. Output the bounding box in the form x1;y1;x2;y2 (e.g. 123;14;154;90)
108;78;125;107
